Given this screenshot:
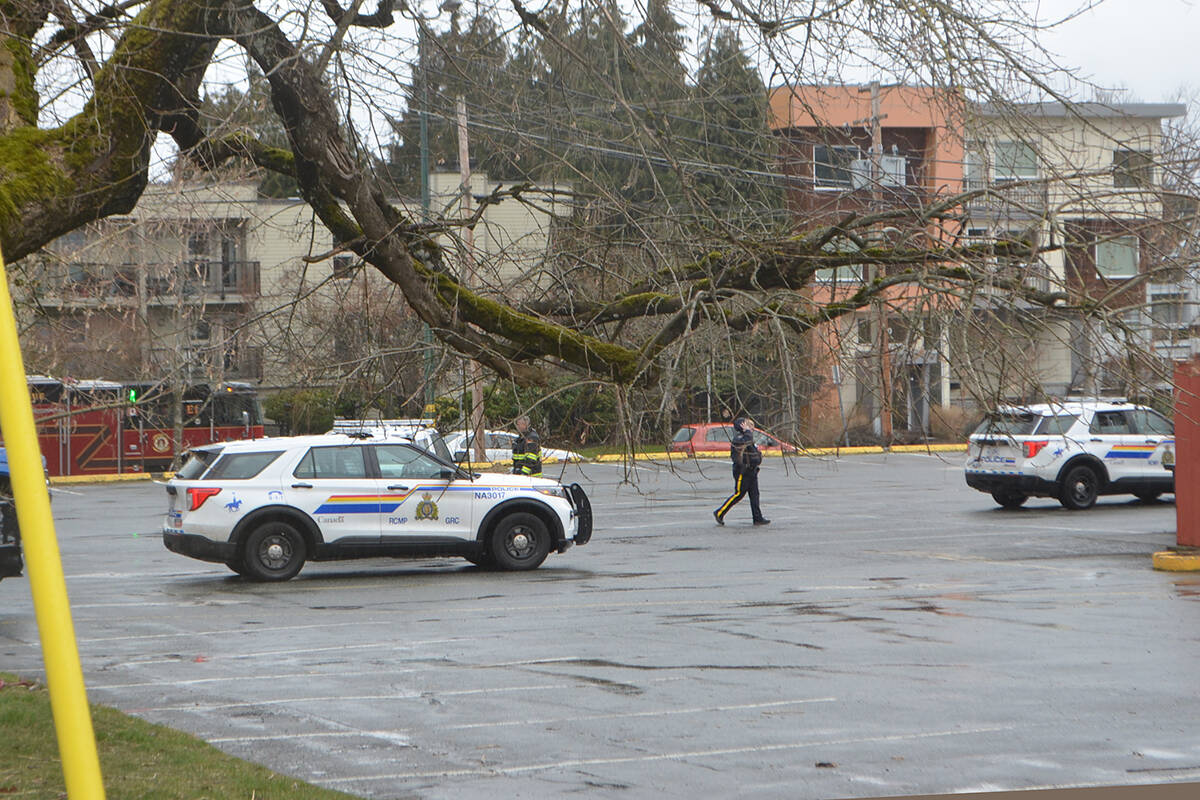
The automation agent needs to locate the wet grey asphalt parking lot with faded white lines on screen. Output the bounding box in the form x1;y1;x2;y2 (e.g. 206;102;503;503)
0;455;1200;799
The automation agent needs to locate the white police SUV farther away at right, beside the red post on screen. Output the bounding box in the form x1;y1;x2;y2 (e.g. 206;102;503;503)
966;399;1175;510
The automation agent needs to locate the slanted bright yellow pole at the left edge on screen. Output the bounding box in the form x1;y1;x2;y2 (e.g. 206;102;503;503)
0;255;104;800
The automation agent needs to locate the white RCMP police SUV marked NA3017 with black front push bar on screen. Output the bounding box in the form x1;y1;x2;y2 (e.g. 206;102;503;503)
162;434;592;581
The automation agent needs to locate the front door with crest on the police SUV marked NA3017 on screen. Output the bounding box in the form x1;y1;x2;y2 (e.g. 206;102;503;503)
372;444;475;541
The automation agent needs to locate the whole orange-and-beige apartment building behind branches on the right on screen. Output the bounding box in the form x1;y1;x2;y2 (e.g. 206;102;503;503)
770;85;1184;435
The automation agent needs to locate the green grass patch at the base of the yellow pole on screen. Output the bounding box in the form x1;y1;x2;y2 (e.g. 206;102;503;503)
0;673;355;800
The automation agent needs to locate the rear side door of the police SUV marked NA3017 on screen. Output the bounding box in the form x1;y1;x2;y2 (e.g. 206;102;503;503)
281;445;379;543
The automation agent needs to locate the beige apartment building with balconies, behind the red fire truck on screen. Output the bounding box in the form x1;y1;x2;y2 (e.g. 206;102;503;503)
16;173;569;391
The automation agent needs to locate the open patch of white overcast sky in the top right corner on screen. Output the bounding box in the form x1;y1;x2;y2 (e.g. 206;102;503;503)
1040;0;1200;103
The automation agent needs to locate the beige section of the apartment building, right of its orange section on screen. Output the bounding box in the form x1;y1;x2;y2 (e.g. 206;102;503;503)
960;103;1186;397
